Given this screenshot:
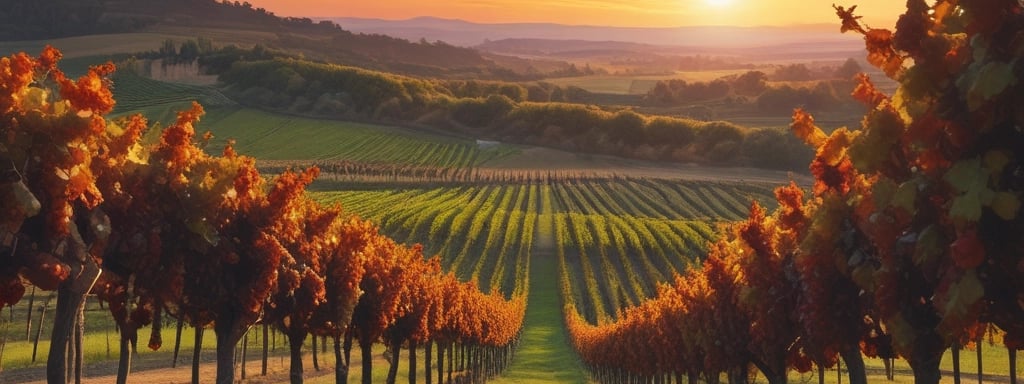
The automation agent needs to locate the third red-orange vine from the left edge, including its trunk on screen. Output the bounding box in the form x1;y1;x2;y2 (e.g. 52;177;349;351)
133;103;305;383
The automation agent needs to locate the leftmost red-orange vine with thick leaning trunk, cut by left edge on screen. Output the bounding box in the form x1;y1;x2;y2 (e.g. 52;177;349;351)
0;46;138;383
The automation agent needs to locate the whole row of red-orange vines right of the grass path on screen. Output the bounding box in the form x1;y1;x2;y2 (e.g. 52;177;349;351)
566;0;1024;383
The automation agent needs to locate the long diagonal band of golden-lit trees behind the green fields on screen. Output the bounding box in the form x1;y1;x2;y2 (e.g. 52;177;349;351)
220;57;811;171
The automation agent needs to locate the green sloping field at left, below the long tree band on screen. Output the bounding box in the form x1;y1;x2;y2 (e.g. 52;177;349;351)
113;73;518;168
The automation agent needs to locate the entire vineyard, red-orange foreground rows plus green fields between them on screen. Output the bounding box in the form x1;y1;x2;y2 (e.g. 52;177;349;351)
0;0;1024;384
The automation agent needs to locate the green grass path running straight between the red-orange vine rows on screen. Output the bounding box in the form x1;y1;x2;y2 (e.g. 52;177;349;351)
489;212;588;384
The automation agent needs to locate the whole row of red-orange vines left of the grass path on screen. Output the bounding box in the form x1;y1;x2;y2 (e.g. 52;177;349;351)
0;47;525;383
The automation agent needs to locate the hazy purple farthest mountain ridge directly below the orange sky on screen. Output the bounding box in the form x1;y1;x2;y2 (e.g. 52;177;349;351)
323;16;862;49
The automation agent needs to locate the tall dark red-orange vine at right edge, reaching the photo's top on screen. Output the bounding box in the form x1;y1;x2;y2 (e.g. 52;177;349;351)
795;1;1022;383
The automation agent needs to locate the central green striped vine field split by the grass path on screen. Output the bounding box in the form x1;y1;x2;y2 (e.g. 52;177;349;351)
314;176;772;321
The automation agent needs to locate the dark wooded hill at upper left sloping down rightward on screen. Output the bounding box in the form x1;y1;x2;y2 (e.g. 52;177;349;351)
0;0;570;80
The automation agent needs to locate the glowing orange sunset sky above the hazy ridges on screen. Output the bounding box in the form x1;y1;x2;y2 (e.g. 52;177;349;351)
250;0;905;28
